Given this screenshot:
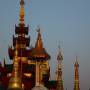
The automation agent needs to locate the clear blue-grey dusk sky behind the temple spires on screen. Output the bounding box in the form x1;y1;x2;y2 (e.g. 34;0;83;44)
0;0;90;90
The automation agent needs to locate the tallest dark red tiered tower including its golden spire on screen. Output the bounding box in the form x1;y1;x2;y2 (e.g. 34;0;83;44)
8;0;30;63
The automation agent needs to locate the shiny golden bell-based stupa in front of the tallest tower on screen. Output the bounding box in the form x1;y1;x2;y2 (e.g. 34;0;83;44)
8;41;23;90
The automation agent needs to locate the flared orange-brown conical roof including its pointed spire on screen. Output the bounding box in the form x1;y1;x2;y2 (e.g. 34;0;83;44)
30;28;50;60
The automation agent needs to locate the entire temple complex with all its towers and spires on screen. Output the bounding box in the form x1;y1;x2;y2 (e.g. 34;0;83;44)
0;0;80;90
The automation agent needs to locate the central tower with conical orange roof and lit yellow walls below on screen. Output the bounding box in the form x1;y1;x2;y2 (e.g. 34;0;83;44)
29;28;50;86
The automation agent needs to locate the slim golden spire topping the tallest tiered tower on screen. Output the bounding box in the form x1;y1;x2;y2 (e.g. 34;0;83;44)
19;0;25;25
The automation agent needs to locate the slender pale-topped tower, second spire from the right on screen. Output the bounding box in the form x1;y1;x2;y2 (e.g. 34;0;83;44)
56;46;64;90
